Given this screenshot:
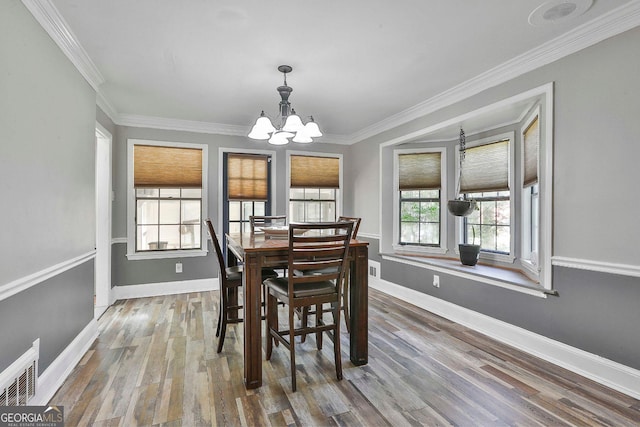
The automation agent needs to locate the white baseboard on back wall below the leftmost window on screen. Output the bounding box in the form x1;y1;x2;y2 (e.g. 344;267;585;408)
111;278;219;301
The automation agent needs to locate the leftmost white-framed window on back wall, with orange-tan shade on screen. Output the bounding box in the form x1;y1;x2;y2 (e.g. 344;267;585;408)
127;140;207;259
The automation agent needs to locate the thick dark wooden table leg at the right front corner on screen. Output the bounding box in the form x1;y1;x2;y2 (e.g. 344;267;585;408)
349;246;369;366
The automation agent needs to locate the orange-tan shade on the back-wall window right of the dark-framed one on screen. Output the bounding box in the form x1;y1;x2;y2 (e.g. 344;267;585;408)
290;156;340;188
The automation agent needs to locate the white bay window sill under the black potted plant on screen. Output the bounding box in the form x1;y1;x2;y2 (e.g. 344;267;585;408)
382;253;557;298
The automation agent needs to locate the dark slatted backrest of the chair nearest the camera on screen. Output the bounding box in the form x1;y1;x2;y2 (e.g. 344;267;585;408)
289;221;353;295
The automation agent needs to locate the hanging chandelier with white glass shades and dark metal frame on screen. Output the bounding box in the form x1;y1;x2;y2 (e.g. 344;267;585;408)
248;65;322;145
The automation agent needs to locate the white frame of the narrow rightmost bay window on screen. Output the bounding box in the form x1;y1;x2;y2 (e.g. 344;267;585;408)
518;106;544;280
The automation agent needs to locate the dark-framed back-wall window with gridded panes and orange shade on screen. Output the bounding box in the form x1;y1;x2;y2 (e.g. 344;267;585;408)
225;153;270;233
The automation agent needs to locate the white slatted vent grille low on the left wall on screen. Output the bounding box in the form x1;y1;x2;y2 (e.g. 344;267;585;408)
0;339;40;406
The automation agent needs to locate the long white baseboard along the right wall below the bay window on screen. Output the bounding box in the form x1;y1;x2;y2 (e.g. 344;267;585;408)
369;276;640;399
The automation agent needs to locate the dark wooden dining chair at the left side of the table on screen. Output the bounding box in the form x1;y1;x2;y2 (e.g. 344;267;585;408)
205;218;278;353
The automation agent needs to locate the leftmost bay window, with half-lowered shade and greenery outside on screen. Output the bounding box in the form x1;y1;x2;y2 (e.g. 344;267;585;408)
394;148;446;253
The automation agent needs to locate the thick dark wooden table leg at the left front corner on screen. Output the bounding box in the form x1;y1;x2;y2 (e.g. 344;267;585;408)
242;254;262;388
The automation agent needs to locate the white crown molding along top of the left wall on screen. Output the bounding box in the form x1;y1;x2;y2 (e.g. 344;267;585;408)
22;0;105;92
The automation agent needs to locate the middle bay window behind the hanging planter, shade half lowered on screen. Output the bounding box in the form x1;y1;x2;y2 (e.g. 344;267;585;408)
460;137;514;261
